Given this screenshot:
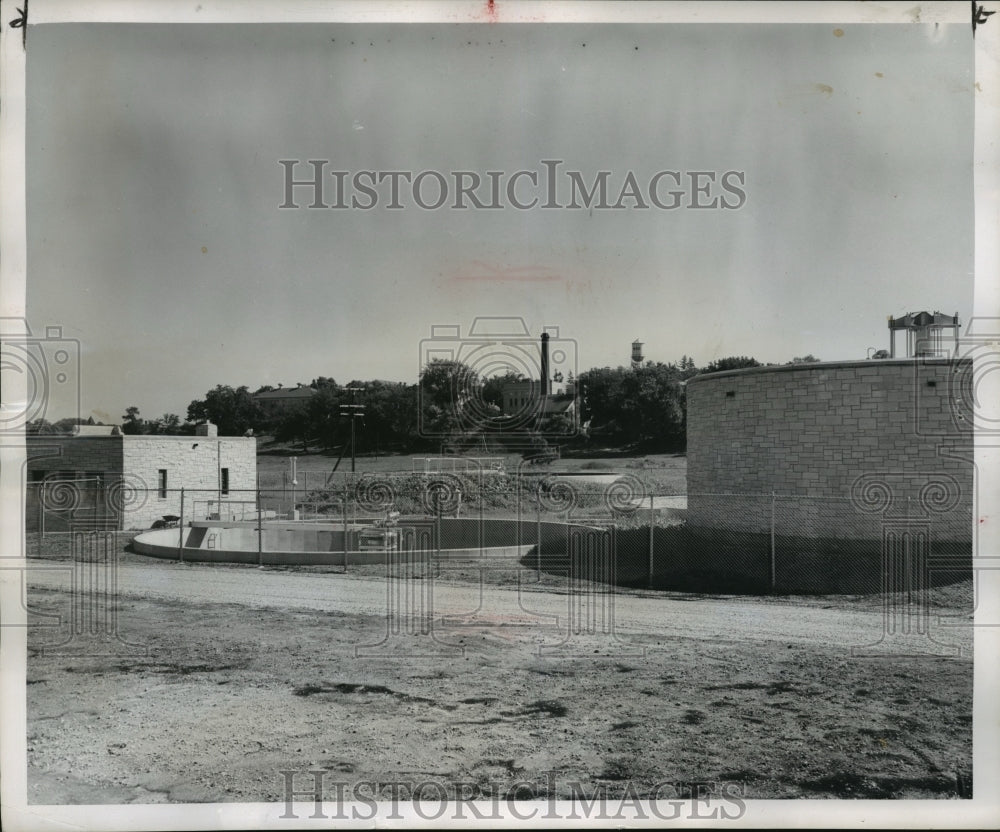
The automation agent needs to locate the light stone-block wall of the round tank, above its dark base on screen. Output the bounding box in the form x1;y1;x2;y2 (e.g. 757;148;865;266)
687;359;973;540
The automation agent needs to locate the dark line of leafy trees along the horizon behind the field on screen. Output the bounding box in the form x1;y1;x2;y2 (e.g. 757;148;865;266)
29;355;819;453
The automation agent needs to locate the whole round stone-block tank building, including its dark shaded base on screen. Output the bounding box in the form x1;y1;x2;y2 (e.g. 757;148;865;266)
687;357;973;592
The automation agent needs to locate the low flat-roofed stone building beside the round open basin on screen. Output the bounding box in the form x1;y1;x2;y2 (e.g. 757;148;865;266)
25;424;257;531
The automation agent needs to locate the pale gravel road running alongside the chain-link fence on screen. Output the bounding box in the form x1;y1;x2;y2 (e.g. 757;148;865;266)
28;560;972;656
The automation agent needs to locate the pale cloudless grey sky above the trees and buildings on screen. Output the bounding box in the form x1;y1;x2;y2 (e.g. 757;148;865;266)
27;23;974;421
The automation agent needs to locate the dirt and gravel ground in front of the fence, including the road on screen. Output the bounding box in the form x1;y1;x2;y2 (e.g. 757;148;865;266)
27;536;973;803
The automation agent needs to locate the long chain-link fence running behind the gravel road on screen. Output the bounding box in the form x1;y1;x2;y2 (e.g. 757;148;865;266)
25;469;972;593
